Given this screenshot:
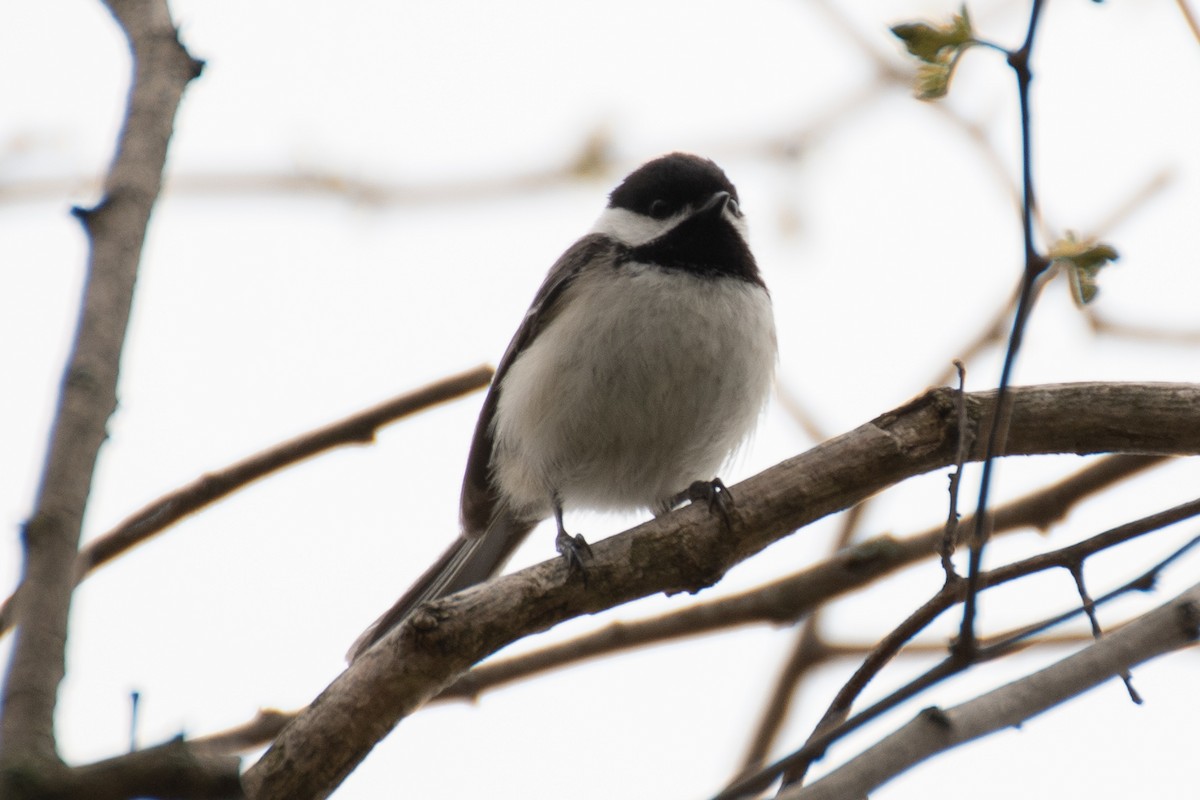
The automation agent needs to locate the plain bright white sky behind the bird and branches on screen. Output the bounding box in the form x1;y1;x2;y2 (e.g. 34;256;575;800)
0;0;1200;800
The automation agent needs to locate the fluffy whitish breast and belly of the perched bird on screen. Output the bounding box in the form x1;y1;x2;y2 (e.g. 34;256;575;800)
492;264;775;515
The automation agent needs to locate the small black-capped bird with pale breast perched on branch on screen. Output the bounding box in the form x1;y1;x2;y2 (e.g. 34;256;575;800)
348;152;778;662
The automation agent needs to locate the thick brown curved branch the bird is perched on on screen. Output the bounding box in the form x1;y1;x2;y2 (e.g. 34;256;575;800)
245;384;1200;800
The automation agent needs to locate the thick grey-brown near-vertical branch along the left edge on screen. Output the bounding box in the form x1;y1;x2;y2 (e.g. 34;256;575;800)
0;0;199;794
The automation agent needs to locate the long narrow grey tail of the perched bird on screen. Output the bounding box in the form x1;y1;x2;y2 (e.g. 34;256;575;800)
346;513;536;662
